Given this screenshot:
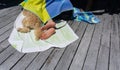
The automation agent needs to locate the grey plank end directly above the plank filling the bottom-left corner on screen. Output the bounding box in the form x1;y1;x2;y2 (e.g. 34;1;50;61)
0;46;16;65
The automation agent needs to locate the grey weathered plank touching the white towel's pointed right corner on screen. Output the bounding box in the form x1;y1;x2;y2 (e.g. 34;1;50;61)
55;23;87;70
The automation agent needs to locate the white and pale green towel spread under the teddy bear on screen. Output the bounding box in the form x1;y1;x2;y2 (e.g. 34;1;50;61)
8;13;78;53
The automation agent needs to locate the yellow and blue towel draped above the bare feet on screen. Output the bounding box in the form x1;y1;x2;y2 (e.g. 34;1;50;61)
20;0;73;23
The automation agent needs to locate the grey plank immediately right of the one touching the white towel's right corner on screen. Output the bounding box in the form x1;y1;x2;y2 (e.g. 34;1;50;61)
69;24;95;70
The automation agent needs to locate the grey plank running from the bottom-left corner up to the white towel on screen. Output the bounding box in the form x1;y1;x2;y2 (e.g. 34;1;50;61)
0;51;24;70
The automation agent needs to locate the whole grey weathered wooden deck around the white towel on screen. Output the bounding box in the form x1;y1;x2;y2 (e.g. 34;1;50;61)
0;6;120;70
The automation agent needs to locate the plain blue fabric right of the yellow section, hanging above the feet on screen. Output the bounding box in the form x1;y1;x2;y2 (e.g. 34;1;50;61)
46;0;74;18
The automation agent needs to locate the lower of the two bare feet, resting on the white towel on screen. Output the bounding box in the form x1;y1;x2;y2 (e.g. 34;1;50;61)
40;28;55;40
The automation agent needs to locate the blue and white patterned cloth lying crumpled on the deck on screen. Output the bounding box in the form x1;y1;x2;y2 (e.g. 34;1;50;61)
73;8;100;23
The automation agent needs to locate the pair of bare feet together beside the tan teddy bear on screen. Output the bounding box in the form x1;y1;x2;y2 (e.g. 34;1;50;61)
40;20;56;40
